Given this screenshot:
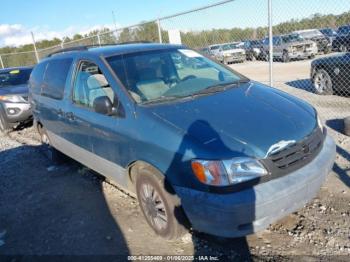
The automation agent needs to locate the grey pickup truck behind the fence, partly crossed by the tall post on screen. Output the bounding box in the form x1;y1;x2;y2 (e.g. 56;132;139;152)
262;34;318;62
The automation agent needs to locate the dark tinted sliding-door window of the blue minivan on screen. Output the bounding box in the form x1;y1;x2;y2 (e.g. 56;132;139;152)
41;58;73;100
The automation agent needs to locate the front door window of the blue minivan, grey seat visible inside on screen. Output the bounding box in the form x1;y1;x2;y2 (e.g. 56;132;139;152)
73;61;115;108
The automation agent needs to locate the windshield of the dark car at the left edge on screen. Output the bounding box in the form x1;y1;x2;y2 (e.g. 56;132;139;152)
0;69;32;87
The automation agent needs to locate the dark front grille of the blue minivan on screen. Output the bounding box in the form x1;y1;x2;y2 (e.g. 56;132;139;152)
269;128;324;170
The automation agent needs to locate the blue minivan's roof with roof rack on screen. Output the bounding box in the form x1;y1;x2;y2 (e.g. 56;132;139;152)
46;43;184;57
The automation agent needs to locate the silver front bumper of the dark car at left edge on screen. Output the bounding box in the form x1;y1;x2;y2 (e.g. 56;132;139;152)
0;102;32;125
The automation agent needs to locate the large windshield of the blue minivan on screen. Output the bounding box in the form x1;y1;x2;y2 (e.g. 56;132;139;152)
107;49;249;103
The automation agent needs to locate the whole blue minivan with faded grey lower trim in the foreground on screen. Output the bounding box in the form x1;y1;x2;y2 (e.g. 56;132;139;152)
30;43;335;239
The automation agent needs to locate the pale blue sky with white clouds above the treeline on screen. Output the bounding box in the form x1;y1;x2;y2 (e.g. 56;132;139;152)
0;0;350;47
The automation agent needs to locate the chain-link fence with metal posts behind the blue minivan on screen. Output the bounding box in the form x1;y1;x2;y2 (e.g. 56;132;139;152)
0;0;350;119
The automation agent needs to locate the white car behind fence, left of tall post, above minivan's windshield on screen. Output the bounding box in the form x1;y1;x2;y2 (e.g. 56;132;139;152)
215;42;246;64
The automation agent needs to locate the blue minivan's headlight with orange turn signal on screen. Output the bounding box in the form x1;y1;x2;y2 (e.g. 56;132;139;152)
192;157;268;186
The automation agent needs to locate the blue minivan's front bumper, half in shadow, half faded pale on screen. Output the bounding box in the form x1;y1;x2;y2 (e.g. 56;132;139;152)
174;136;336;237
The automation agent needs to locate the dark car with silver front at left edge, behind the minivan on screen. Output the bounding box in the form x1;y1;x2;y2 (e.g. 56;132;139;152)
0;67;32;133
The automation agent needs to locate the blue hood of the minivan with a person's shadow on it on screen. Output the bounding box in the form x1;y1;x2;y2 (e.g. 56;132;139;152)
147;82;317;159
